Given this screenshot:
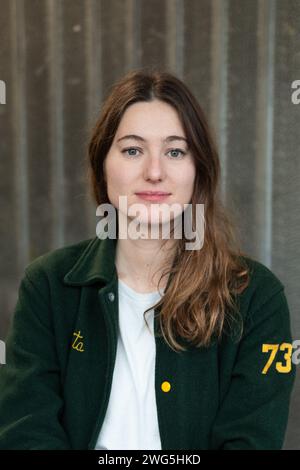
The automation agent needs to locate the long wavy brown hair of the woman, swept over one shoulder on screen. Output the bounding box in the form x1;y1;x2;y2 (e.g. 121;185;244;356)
87;67;250;351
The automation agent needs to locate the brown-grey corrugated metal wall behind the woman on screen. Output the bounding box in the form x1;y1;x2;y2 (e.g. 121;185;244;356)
0;0;300;449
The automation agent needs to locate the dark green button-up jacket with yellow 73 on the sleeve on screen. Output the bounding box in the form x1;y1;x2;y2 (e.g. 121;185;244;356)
0;237;295;450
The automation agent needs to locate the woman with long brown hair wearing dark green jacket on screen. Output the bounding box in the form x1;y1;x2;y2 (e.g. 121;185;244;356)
0;69;295;450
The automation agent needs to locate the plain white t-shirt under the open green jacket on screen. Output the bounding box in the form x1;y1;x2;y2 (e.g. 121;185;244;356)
95;279;164;450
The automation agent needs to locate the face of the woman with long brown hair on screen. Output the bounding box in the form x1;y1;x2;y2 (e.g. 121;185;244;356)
104;100;196;235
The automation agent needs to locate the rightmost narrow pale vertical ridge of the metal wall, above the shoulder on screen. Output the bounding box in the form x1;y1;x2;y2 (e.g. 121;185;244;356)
255;0;275;267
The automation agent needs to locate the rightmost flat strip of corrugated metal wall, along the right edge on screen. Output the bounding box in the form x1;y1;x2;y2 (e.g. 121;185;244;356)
271;0;300;449
